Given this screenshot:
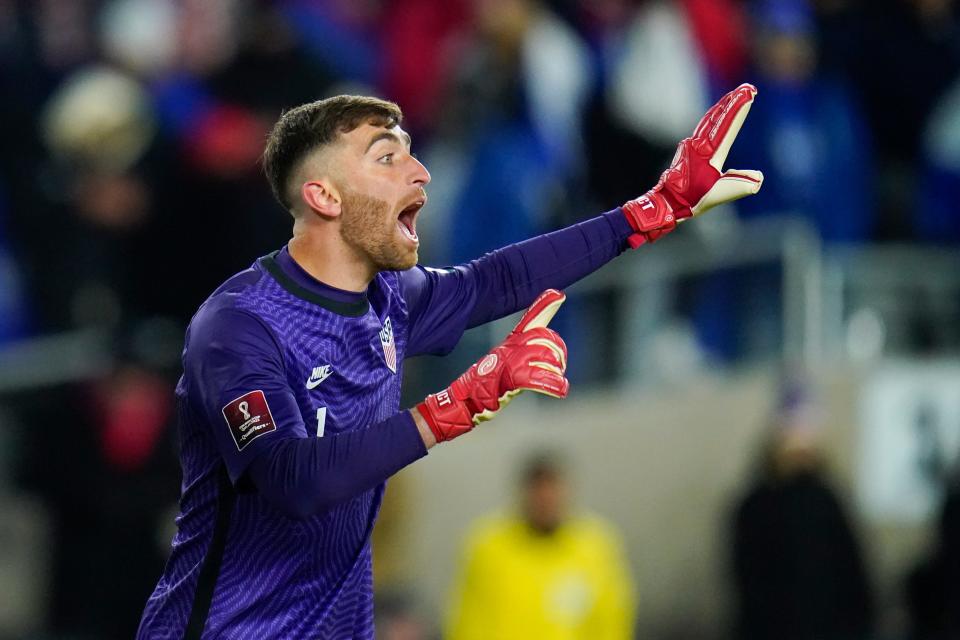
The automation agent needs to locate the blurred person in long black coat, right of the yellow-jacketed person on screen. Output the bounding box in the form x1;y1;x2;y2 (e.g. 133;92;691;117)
732;384;873;640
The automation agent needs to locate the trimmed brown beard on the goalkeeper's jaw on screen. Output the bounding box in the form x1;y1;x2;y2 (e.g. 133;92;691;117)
340;189;417;271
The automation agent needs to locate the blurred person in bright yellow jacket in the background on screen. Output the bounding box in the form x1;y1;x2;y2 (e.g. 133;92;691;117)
445;454;636;640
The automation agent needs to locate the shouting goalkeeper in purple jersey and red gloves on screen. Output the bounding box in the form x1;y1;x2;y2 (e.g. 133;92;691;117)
138;85;762;639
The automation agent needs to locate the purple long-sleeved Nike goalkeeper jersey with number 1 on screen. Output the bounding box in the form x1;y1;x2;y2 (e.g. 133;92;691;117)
137;210;632;640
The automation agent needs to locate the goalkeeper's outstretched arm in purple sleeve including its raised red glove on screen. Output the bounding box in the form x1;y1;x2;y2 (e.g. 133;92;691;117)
401;84;763;356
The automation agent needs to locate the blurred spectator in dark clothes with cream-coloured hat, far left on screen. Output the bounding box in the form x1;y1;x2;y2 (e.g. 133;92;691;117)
17;65;163;331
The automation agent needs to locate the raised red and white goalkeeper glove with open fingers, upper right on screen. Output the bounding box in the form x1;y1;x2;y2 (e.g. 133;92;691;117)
623;84;763;249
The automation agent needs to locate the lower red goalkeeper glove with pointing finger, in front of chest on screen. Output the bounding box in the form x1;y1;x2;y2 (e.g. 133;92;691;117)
417;289;570;442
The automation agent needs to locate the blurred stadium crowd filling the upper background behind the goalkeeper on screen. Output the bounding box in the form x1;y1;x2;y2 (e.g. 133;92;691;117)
0;0;960;339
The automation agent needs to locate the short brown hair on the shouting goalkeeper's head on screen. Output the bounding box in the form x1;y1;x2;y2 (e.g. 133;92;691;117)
263;96;403;210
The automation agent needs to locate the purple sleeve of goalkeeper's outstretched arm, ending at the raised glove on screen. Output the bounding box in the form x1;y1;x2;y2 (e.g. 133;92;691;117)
401;209;633;356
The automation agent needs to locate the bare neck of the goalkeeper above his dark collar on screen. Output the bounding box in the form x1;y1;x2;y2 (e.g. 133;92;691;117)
287;221;377;292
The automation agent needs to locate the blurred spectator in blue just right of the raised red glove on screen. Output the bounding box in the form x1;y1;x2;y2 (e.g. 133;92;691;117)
728;0;875;242
